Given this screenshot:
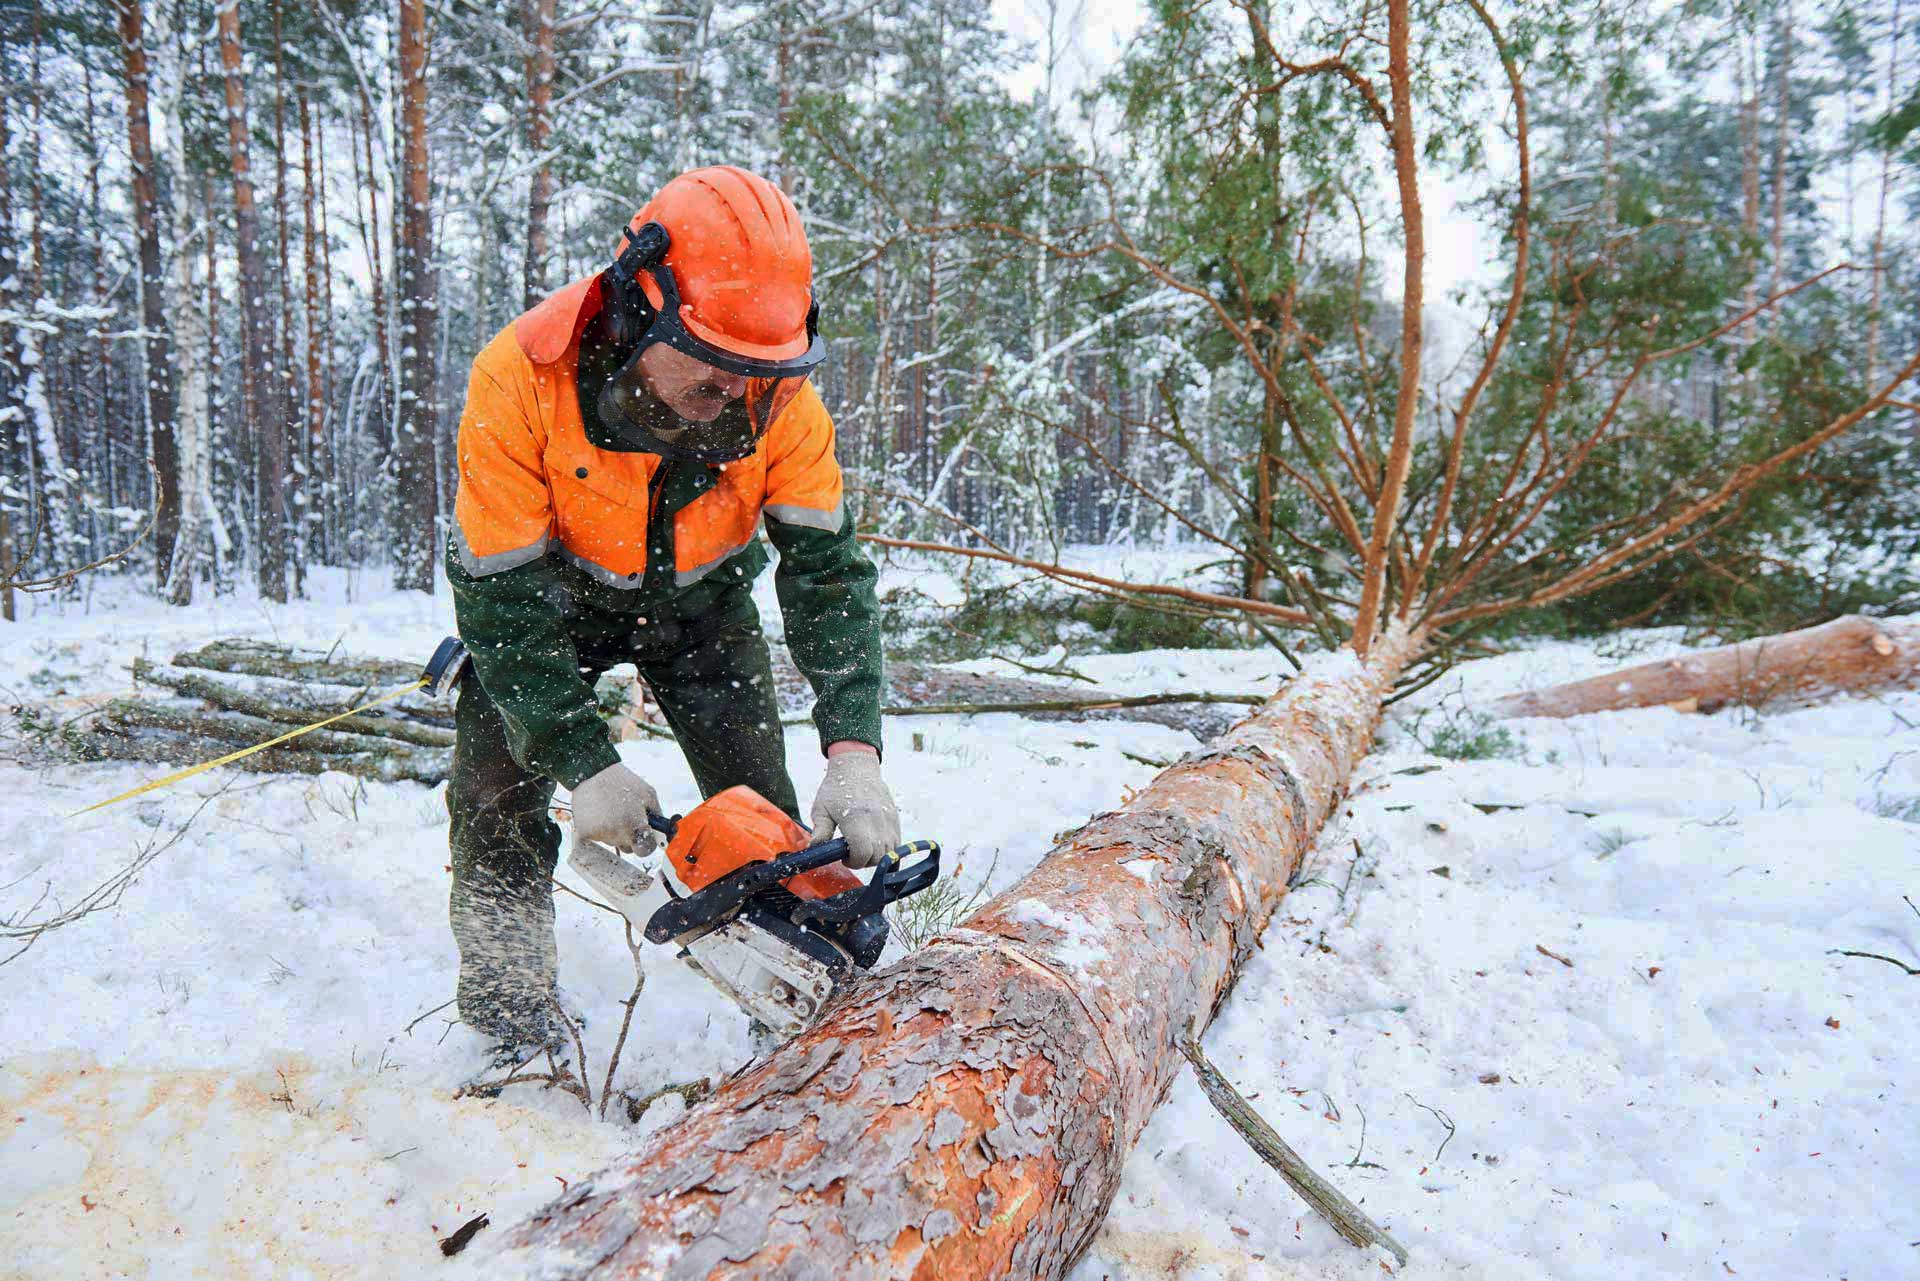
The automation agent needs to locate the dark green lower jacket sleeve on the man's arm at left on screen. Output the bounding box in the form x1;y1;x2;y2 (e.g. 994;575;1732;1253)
447;537;620;789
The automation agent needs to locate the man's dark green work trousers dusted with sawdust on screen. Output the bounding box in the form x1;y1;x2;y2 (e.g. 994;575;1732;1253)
447;588;801;1043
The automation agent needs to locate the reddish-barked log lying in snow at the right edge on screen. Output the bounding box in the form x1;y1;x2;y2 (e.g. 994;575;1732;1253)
1490;615;1920;716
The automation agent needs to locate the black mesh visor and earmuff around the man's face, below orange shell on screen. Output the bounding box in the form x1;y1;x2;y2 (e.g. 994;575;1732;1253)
595;223;826;463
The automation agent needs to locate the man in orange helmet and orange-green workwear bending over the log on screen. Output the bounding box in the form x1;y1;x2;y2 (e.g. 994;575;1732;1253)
447;167;900;1047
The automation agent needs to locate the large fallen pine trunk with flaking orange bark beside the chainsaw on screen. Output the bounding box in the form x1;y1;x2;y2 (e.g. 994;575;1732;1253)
478;630;1421;1281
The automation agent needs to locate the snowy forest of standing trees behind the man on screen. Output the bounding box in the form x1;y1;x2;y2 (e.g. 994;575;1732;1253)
0;0;1920;645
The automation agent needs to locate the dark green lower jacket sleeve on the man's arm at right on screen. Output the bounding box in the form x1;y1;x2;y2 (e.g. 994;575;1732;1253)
766;513;885;751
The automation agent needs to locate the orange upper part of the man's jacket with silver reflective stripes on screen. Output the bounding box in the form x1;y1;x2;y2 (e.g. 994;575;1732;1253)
453;290;845;590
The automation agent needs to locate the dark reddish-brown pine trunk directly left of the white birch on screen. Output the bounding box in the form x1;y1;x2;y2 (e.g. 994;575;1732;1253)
119;0;184;586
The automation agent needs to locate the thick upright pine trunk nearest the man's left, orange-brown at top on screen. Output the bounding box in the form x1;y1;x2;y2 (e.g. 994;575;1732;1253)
394;0;440;592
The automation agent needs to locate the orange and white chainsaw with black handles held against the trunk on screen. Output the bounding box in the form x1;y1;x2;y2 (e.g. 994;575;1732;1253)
422;636;941;1037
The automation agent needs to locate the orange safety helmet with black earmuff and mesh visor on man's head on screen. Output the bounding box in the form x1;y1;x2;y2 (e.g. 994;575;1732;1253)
597;165;826;463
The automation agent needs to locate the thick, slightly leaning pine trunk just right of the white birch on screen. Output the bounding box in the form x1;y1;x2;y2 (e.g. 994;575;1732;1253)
219;0;288;601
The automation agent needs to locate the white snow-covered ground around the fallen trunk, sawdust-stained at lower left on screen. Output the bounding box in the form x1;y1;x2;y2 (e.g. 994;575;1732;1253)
0;578;1920;1281
